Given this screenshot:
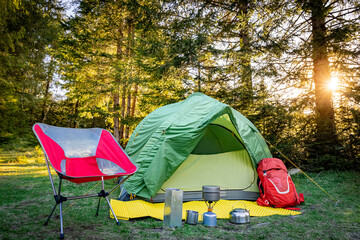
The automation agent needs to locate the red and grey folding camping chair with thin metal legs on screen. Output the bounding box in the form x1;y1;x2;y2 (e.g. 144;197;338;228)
33;123;137;239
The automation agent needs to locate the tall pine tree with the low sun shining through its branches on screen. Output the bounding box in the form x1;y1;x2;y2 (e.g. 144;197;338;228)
264;0;359;168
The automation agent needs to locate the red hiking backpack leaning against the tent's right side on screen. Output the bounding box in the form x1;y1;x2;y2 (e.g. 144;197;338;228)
256;158;304;208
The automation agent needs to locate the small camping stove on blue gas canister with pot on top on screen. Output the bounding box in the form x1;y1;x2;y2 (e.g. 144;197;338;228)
202;186;220;226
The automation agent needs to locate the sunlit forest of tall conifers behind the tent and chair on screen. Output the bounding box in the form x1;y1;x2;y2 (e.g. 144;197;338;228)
0;0;360;171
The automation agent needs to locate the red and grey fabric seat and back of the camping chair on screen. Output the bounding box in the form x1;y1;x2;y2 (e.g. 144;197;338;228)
33;123;137;180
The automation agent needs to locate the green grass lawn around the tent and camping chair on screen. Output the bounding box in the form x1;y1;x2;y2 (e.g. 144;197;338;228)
0;149;360;239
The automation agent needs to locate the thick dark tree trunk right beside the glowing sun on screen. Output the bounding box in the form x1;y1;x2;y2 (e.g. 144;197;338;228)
311;0;337;155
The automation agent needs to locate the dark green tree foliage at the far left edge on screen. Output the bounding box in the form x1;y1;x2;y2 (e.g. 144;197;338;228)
0;0;62;141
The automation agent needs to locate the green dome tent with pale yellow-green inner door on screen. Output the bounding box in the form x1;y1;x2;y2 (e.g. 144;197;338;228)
124;93;271;201
